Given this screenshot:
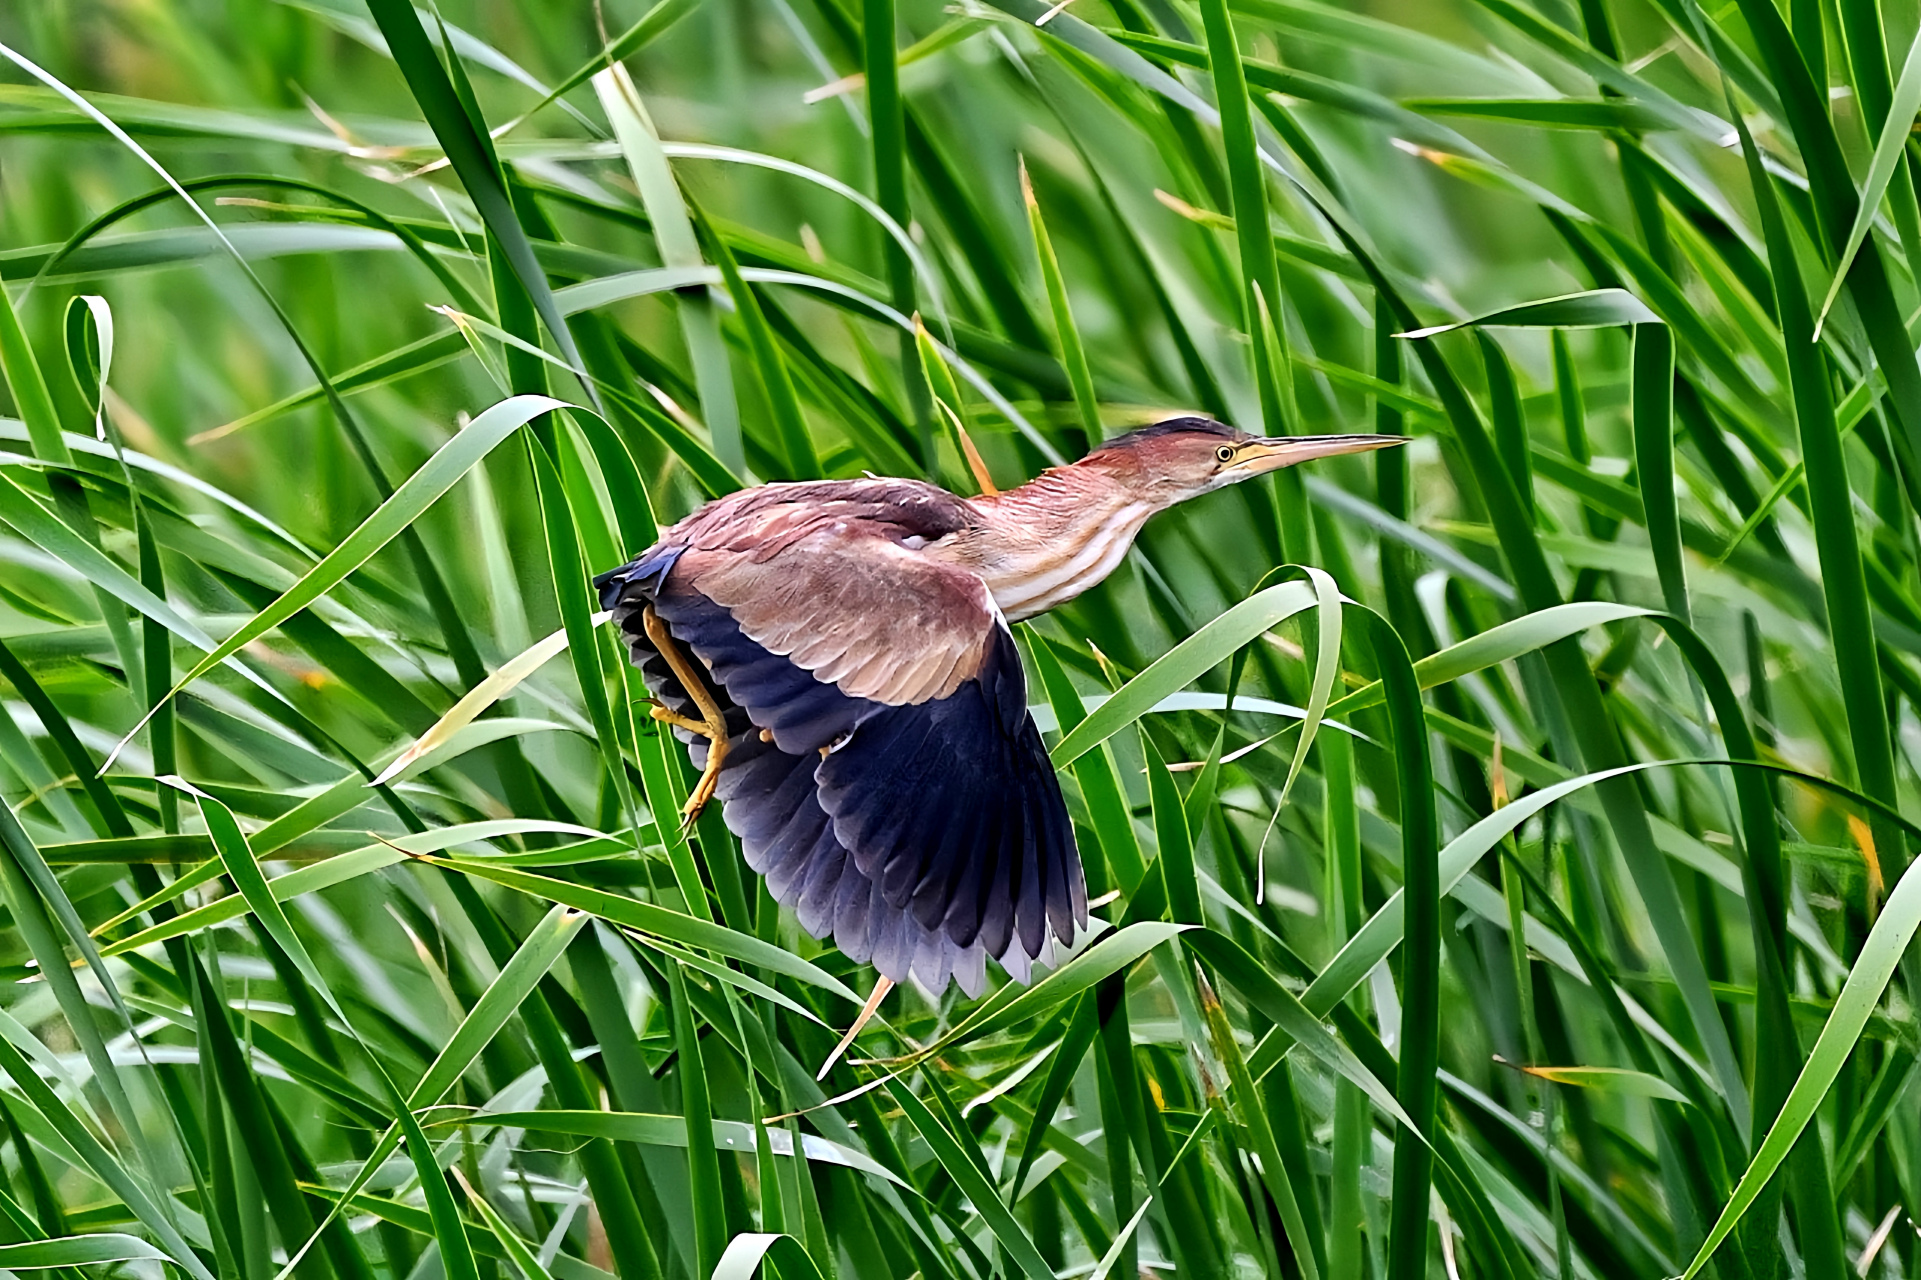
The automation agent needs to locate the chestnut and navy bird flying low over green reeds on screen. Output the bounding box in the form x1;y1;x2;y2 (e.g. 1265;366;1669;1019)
594;417;1402;1007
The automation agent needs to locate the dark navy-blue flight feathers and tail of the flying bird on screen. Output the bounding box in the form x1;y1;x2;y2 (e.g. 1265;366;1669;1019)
596;550;1087;994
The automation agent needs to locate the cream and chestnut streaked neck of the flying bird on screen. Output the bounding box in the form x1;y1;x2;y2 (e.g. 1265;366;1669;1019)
962;465;1160;621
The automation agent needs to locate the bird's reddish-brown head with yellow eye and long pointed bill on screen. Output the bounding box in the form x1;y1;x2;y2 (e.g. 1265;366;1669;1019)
1076;417;1406;507
